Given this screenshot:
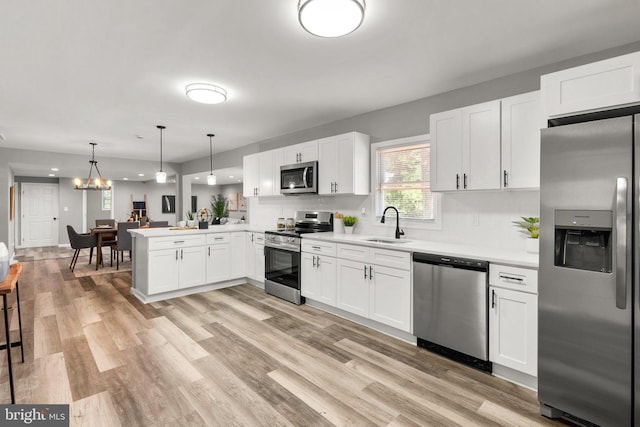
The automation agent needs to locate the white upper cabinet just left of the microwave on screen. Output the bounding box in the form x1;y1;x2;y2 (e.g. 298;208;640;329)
242;150;280;197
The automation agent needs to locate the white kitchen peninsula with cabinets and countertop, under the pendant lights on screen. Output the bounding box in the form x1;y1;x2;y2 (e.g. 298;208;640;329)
130;224;261;303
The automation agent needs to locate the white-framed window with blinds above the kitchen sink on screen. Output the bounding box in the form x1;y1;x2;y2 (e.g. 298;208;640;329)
372;136;438;225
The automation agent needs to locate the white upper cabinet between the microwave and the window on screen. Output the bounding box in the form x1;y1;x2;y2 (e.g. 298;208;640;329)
318;132;371;195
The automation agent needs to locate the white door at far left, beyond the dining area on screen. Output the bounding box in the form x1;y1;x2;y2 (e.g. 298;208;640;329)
20;183;59;248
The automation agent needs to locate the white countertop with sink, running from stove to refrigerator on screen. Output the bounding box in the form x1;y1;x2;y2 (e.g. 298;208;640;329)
302;233;538;268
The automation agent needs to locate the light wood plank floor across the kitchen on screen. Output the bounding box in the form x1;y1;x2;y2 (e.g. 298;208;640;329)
0;249;560;427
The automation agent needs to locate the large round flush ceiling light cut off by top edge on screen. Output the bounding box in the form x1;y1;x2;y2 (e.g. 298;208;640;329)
298;0;365;37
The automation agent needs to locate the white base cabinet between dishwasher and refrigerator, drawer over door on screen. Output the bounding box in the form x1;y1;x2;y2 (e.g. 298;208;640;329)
489;264;538;377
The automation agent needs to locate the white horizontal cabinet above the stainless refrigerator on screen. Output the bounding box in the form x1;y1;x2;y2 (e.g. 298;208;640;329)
540;52;640;118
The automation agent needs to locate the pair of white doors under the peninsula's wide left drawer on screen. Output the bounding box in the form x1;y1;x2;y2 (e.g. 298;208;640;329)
149;246;206;295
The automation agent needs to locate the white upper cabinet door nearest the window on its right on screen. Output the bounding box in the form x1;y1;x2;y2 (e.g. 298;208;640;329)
429;109;462;191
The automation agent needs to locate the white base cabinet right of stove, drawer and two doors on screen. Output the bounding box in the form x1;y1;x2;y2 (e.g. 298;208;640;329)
301;239;336;307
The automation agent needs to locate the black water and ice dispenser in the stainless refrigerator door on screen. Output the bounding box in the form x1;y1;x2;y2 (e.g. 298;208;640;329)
554;210;613;273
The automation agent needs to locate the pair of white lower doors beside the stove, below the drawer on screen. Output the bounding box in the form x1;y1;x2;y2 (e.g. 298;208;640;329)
301;252;336;306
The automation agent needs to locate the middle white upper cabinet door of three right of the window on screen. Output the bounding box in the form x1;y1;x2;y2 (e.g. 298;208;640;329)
462;101;500;190
